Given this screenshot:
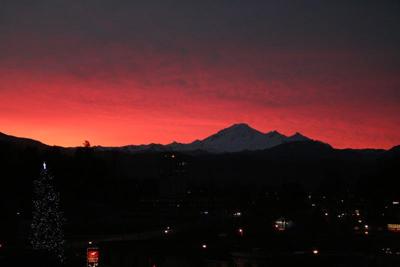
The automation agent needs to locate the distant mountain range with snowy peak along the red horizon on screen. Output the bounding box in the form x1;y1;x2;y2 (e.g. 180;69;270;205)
0;123;399;154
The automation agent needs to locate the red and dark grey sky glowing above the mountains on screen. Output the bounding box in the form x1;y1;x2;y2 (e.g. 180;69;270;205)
0;0;400;148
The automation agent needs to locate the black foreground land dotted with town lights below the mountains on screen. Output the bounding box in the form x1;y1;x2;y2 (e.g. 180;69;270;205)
0;134;400;267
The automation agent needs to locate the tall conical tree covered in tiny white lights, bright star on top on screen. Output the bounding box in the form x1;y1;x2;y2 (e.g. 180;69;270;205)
31;163;65;262
